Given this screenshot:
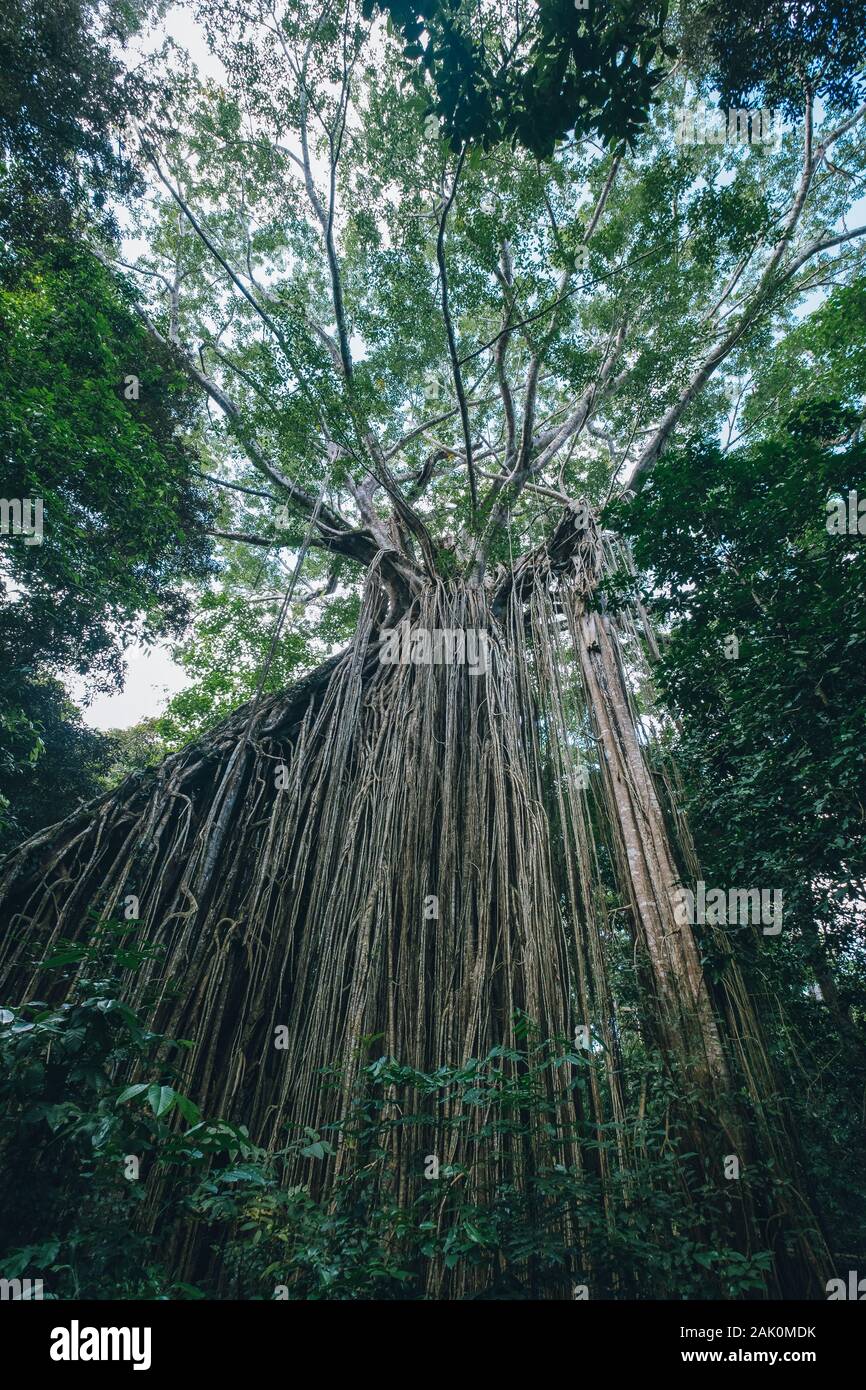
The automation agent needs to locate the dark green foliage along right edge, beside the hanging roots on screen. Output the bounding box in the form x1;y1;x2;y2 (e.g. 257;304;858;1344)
610;405;866;1250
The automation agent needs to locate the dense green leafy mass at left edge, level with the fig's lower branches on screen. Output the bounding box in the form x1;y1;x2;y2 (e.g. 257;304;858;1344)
0;245;216;689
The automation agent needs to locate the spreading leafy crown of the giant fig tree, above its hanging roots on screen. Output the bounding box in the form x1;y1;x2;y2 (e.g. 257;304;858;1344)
100;3;863;739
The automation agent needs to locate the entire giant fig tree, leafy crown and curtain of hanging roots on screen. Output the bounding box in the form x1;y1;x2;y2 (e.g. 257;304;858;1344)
0;0;866;1293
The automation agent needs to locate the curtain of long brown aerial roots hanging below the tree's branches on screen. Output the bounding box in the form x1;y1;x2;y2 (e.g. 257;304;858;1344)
0;533;839;1294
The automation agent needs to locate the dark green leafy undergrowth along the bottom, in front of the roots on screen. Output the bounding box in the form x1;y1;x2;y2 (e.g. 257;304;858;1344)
0;939;770;1300
